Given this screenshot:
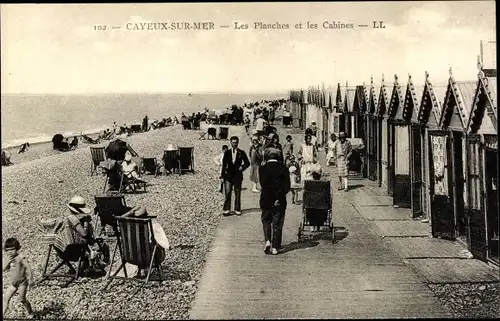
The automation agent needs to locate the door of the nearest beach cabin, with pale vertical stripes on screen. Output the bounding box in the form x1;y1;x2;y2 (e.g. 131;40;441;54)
467;135;487;261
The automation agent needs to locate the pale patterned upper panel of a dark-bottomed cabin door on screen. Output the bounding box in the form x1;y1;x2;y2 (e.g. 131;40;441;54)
431;136;448;195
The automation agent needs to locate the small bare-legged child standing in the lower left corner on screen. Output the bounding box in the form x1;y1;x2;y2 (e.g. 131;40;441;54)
3;237;34;317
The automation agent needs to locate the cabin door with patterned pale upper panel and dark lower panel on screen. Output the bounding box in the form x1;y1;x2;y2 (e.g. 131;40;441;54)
429;131;456;240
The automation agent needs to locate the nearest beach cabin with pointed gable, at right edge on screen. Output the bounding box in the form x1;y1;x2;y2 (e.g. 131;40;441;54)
466;64;499;265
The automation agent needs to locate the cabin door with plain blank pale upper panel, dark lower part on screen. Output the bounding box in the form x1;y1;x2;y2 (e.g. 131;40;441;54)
393;125;412;208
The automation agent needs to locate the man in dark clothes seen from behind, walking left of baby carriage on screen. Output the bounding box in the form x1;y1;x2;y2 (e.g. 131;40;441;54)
259;148;290;255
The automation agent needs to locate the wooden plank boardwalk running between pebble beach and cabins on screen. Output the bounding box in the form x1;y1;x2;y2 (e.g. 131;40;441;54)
190;125;450;319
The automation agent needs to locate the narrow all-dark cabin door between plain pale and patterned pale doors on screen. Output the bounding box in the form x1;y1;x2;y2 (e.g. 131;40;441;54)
410;125;423;217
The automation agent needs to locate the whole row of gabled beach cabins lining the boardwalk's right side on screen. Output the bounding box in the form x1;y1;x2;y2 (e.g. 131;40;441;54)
288;57;499;265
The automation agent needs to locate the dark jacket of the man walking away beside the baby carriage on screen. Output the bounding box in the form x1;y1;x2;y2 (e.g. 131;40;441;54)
259;162;290;209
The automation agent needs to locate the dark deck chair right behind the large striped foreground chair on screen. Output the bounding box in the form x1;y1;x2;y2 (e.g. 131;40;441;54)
94;194;130;235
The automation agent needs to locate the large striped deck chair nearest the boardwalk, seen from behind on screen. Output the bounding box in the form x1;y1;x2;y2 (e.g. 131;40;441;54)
104;216;165;288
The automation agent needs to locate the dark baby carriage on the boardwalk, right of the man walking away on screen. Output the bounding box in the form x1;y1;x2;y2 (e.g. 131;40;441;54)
297;180;335;243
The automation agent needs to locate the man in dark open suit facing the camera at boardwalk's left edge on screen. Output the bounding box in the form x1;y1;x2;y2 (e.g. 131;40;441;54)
220;136;250;216
